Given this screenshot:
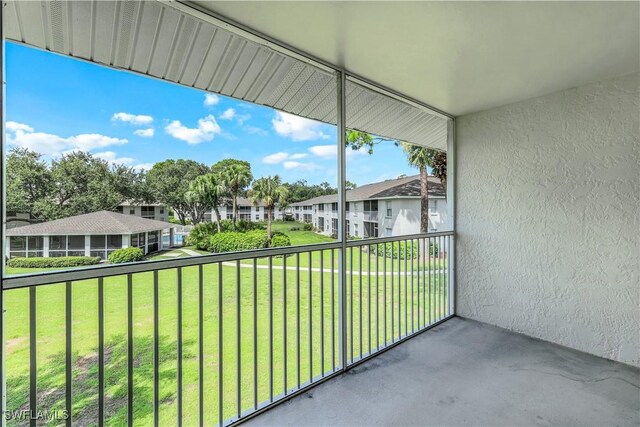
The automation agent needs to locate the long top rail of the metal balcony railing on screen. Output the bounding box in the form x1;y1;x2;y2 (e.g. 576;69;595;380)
2;231;453;291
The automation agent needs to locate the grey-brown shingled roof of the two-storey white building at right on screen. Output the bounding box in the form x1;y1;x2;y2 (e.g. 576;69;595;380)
291;175;446;206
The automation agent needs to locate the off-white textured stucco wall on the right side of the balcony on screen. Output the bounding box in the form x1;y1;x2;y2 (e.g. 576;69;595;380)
456;74;640;366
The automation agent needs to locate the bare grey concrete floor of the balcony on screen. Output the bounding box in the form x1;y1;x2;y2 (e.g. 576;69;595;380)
247;318;640;426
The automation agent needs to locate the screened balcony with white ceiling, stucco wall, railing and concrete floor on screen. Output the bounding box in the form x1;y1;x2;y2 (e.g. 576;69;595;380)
1;1;640;426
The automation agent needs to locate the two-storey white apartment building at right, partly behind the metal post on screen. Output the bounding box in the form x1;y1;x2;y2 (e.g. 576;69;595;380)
291;175;450;237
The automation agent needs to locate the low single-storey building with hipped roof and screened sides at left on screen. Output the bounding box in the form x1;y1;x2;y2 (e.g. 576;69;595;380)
5;211;174;260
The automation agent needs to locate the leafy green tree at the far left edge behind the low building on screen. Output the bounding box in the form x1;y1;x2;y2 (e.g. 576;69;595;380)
6;148;53;216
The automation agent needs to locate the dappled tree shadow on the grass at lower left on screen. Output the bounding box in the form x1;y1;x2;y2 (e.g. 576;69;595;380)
7;335;196;426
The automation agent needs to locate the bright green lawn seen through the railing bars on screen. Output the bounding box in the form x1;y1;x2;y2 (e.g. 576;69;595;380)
5;223;446;425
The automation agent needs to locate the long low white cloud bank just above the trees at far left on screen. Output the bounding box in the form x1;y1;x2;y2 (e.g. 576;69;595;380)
7;122;128;156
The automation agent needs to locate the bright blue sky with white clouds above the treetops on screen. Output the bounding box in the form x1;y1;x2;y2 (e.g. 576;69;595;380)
6;42;417;185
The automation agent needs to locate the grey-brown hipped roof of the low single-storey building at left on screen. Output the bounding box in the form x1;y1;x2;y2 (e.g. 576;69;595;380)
7;211;173;236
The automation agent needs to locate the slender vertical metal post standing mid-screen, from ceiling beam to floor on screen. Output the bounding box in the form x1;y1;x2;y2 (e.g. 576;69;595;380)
337;71;347;371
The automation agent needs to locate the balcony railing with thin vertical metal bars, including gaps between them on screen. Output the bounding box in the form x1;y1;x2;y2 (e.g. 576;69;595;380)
3;232;454;425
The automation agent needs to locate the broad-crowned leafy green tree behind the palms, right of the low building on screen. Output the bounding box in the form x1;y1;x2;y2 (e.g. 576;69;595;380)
147;159;209;225
